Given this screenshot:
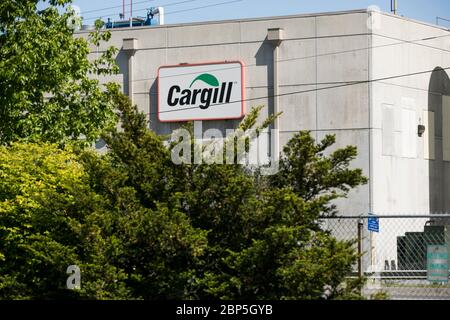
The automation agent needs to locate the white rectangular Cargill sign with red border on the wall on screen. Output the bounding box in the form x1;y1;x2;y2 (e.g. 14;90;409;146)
158;61;245;122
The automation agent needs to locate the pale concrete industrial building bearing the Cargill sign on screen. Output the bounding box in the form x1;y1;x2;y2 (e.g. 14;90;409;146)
77;10;450;270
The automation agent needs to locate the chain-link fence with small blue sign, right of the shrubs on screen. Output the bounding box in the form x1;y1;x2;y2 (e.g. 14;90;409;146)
321;215;450;300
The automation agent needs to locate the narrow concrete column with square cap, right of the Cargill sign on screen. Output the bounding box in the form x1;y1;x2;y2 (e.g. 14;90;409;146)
267;28;283;161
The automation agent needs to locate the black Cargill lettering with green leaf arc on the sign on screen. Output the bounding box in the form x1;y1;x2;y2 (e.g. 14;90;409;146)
167;73;233;109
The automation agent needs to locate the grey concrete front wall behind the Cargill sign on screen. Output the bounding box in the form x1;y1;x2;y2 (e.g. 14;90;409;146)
76;11;371;215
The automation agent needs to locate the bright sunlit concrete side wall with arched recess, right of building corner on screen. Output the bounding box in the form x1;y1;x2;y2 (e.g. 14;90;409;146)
370;13;450;270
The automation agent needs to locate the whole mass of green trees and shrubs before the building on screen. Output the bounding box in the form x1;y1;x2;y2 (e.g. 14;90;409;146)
0;0;367;299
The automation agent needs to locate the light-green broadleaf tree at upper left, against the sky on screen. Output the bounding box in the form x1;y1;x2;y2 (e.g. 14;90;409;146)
0;0;118;144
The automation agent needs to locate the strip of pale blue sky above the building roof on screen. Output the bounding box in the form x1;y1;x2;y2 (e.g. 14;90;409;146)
53;0;450;27
